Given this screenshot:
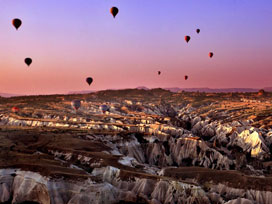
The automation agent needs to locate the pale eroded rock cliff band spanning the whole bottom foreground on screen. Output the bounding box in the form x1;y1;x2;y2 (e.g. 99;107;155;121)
0;167;272;204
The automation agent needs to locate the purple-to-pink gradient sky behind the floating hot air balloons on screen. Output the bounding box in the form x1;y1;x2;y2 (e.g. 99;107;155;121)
0;0;272;95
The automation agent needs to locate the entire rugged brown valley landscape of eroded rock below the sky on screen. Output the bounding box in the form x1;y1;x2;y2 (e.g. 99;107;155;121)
0;90;272;204
